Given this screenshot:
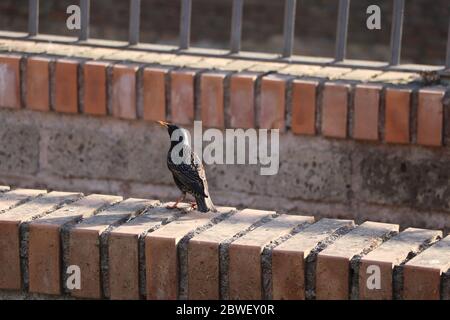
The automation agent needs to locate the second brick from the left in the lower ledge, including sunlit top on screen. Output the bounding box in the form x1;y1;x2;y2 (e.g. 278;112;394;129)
28;194;122;295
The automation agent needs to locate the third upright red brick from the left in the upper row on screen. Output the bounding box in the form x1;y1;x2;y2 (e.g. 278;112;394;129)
54;59;78;113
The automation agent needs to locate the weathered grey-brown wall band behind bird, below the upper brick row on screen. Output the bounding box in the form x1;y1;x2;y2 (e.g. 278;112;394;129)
0;108;450;230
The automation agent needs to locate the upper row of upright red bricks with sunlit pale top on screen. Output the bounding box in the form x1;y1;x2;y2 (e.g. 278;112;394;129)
0;40;446;154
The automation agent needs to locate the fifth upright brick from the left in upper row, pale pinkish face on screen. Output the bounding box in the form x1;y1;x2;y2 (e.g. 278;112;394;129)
111;64;138;120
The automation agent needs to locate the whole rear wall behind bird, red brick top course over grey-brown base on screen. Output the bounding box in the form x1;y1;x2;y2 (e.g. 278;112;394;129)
0;40;450;235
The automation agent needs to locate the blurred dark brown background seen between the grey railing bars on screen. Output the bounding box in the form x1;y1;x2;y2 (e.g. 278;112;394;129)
0;0;450;64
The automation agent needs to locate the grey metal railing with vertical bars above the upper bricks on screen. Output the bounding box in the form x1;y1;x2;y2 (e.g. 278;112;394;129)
3;0;450;69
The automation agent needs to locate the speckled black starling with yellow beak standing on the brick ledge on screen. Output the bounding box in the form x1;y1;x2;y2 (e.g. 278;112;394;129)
157;120;217;212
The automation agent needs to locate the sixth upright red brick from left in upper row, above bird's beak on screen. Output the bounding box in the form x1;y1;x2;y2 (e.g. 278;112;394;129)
143;68;168;121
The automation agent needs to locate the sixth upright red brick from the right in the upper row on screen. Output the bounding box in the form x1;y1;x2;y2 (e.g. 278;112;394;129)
259;75;287;132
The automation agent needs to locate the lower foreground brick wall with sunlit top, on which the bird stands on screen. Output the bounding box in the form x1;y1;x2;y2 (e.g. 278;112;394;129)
0;186;450;300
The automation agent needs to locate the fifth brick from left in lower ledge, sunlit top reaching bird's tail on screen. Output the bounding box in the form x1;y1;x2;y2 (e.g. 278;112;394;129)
145;212;217;300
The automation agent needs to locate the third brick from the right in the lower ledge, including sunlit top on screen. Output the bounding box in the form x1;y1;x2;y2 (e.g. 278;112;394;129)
316;222;399;300
